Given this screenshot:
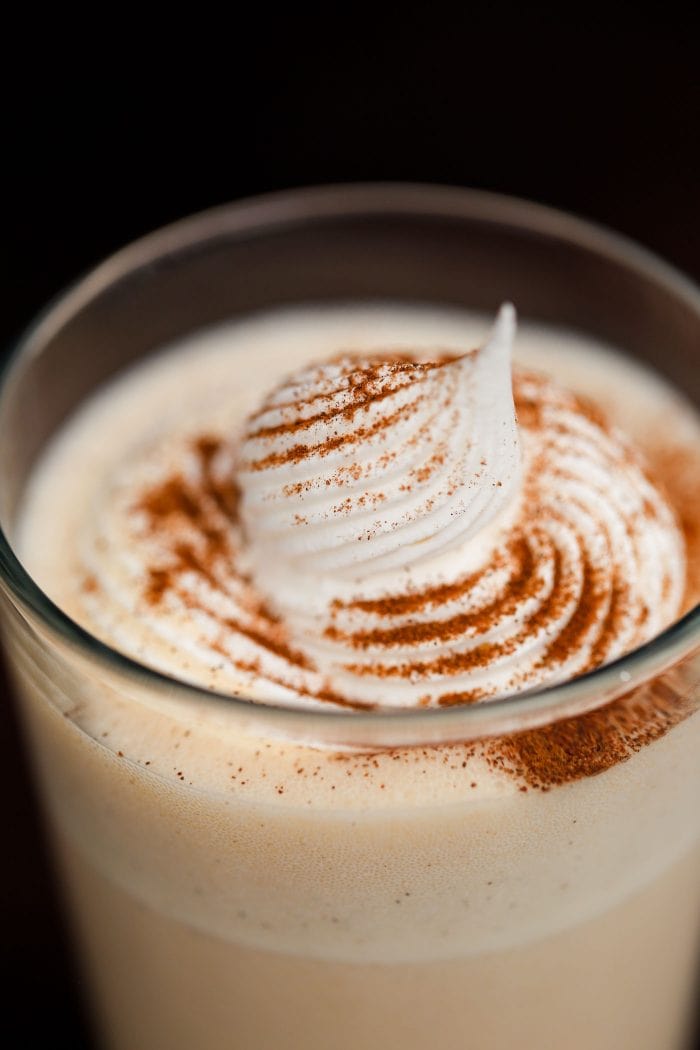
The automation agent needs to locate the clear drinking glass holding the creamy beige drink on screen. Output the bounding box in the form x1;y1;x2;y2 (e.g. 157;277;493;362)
0;186;700;1050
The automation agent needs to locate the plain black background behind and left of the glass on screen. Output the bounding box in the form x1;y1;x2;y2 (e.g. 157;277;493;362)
0;16;700;1050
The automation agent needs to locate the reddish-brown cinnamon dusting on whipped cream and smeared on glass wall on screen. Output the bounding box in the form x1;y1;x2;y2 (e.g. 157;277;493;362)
120;362;700;790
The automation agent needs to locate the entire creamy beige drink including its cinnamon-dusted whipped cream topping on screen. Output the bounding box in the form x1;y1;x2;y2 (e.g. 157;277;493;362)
6;303;700;1050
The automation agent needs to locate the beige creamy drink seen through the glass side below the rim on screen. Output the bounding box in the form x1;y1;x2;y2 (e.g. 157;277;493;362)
5;304;700;1050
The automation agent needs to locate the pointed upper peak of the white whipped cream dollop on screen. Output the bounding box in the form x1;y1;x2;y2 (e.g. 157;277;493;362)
237;305;521;582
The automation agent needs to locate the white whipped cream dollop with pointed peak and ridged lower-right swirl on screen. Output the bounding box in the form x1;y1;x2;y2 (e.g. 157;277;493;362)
229;306;684;706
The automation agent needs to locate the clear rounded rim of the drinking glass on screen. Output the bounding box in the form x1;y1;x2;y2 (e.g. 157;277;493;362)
0;183;700;747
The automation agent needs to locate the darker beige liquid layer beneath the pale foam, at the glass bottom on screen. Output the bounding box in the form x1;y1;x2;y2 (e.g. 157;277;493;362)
57;847;700;1050
